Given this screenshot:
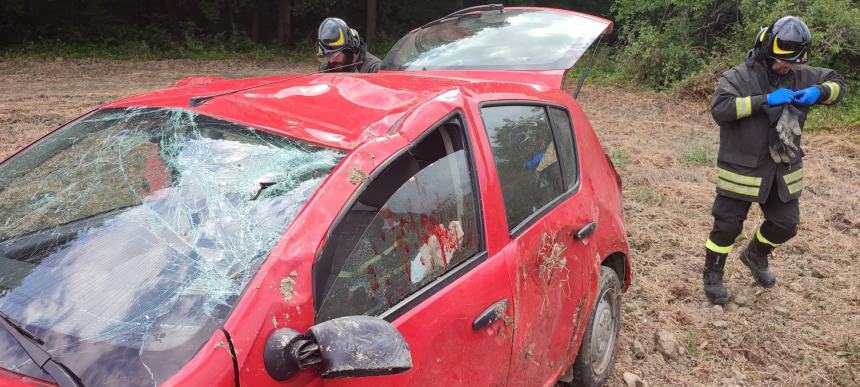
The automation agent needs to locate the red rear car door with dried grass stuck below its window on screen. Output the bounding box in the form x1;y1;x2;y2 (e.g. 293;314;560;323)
481;102;597;386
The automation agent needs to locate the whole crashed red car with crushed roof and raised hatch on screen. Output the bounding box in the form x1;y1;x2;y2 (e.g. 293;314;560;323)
0;6;630;386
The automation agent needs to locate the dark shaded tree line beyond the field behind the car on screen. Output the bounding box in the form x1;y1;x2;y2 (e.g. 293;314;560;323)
0;0;611;47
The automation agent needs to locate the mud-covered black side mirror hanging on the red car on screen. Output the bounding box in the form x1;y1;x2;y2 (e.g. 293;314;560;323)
263;316;412;380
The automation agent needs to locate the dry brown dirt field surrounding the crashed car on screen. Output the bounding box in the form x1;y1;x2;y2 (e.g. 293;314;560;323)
0;60;860;386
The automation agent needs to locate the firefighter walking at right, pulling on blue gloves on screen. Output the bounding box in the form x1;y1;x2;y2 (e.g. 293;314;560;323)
703;16;847;304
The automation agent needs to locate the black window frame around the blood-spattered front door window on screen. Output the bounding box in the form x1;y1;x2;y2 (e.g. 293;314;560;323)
311;108;489;324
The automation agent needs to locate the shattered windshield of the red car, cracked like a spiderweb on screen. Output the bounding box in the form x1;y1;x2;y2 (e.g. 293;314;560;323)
0;108;343;386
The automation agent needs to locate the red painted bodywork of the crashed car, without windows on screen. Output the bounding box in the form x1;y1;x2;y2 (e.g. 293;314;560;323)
0;6;630;387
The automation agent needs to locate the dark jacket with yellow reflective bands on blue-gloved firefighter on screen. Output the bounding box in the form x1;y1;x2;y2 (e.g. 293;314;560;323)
711;53;847;203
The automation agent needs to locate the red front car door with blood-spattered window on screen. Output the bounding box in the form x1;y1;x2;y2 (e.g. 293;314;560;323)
314;113;512;386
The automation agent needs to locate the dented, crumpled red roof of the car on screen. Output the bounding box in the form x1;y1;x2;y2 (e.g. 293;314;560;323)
104;73;478;149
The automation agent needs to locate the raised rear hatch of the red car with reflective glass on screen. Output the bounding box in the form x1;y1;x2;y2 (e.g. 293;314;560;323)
382;9;609;71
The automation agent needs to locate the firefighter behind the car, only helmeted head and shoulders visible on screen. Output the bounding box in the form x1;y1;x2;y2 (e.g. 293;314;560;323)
317;17;382;73
